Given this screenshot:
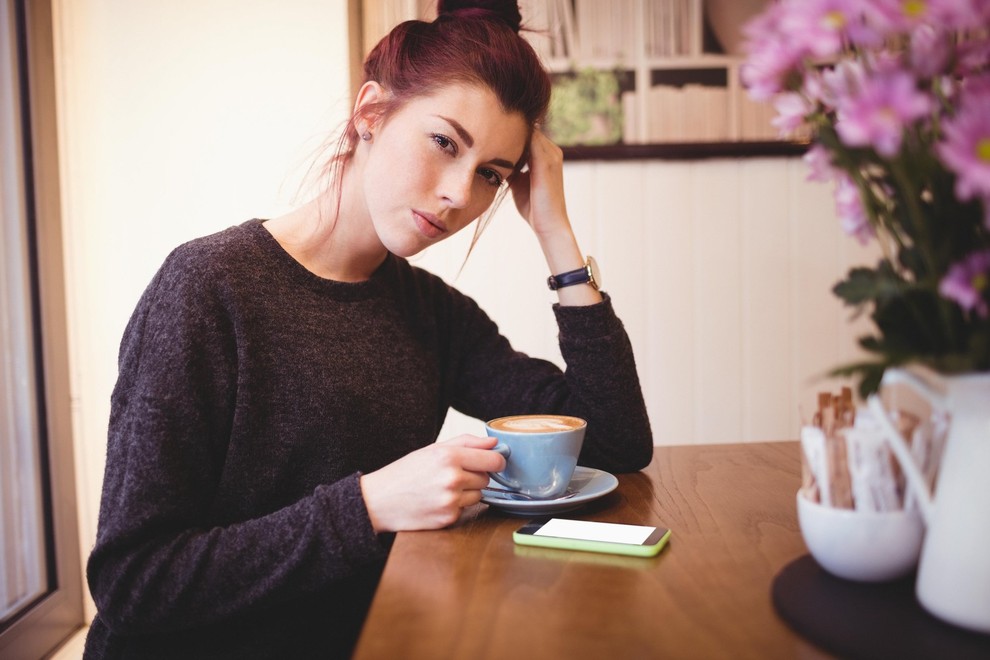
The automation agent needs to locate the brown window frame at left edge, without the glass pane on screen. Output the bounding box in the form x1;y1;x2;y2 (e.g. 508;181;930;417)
0;0;84;658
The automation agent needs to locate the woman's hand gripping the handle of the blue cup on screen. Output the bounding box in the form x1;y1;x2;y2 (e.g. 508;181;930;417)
361;435;505;532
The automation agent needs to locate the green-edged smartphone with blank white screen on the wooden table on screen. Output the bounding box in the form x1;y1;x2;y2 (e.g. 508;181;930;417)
512;518;670;557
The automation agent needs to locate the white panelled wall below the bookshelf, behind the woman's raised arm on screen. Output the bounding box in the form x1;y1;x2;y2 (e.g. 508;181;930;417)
419;158;872;444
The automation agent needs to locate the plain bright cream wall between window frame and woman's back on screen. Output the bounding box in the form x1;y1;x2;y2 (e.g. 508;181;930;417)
53;0;349;615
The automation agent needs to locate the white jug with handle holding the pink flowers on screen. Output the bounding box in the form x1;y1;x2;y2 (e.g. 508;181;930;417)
869;369;990;633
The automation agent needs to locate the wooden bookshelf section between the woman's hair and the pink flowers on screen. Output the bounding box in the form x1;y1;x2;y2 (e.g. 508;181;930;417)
520;0;789;153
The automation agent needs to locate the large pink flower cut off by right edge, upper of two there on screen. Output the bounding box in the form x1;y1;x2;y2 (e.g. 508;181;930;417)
935;81;990;201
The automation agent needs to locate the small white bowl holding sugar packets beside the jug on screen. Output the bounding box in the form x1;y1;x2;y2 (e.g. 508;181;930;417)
797;492;925;582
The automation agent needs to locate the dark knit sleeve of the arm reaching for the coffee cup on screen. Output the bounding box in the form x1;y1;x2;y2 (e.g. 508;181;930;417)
88;249;387;634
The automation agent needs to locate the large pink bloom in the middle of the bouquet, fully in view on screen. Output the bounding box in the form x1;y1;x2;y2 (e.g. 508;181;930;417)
835;71;934;158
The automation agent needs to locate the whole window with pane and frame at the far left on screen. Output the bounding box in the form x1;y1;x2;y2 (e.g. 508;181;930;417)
0;0;83;658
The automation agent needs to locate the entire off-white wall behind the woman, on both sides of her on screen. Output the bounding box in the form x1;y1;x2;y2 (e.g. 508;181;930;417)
54;0;862;614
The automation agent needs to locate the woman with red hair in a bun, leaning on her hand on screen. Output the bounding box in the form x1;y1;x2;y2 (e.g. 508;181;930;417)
86;2;652;658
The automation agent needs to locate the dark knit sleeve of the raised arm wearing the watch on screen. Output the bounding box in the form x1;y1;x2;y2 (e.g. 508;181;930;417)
453;294;653;472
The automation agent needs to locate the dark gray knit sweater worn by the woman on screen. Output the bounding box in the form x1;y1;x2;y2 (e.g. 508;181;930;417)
86;221;652;658
